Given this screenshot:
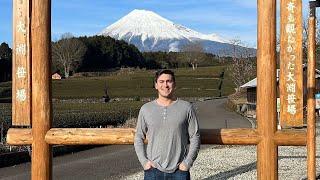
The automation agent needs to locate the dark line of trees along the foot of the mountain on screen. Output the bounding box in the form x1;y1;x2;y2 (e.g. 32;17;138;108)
0;33;231;81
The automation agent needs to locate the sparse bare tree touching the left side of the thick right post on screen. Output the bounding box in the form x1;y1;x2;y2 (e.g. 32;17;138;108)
228;39;256;91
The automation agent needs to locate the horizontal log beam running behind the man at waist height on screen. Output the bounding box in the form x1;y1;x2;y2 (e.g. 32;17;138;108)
7;128;306;146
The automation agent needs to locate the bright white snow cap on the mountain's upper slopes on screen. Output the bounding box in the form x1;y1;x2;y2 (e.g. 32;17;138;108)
99;9;225;43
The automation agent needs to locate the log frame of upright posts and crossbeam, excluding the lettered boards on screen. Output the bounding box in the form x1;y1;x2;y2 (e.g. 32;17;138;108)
7;0;316;180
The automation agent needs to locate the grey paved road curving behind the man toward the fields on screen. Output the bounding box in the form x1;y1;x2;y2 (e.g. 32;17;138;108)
0;99;251;180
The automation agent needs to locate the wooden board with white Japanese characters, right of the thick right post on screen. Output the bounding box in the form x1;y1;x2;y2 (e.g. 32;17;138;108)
279;0;303;127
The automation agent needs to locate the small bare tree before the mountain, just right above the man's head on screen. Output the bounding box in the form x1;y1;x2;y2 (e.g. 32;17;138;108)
182;42;205;70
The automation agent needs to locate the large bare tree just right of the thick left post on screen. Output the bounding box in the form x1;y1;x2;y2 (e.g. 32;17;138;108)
52;33;87;78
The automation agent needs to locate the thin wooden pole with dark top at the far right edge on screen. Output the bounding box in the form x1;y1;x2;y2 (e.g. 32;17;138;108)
307;3;316;180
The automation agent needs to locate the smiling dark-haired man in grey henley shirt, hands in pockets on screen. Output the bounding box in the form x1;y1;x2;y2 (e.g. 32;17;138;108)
134;70;200;180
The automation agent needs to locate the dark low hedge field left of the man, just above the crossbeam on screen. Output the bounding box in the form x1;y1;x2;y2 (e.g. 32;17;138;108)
0;101;145;140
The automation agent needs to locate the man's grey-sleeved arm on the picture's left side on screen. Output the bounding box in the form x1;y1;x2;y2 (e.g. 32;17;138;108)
134;108;148;167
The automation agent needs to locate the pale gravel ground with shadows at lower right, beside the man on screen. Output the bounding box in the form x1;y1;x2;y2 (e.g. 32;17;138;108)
123;139;320;180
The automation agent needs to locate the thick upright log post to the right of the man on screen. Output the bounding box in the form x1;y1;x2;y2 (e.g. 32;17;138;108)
257;0;278;179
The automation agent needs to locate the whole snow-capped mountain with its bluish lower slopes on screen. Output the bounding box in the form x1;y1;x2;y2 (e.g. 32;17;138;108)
98;9;254;55
